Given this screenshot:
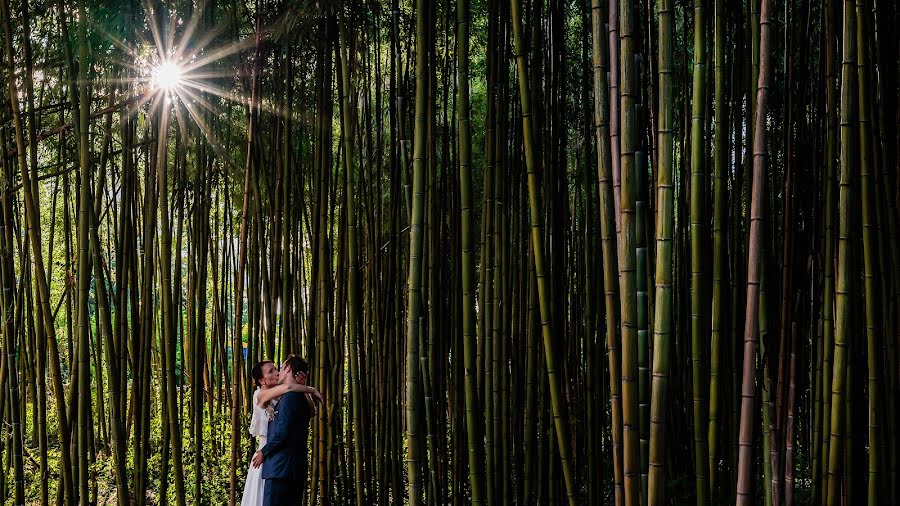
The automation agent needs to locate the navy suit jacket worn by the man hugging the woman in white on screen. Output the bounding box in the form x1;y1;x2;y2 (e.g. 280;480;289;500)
260;392;312;481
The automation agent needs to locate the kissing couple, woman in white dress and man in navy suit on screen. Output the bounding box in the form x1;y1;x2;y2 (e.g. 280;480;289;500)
241;355;322;506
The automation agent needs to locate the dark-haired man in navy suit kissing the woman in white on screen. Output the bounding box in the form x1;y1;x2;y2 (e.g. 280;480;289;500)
253;355;313;506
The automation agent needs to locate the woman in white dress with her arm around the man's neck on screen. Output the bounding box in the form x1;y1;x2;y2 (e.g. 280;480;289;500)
241;361;323;506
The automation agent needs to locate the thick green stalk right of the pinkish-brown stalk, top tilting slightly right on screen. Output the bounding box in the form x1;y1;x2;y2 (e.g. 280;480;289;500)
825;0;858;500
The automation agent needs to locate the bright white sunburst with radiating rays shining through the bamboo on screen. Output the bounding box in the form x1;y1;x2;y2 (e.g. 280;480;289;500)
92;0;296;164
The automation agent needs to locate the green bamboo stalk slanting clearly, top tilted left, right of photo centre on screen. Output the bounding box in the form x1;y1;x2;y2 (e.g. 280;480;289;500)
510;0;572;505
